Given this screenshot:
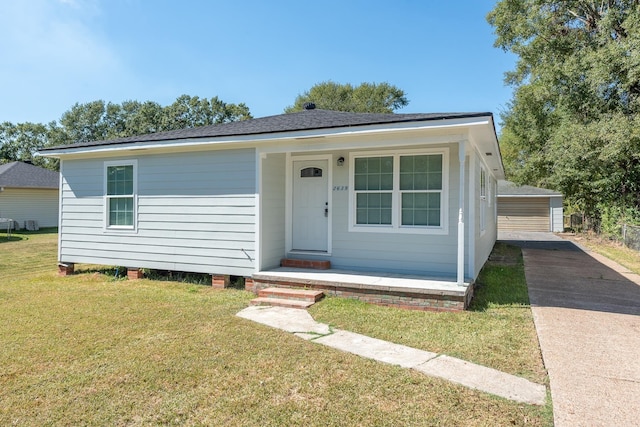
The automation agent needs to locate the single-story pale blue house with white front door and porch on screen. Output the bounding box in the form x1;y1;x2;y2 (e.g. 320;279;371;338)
40;104;504;308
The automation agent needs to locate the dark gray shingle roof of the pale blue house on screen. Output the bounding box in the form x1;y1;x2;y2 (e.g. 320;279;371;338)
40;109;492;153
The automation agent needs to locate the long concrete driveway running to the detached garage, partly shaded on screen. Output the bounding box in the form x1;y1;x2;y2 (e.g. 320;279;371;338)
498;233;640;426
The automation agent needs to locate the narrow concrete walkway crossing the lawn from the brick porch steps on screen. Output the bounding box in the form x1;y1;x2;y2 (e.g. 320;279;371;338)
237;306;546;405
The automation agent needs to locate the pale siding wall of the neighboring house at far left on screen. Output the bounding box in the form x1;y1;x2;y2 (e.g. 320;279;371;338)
0;188;59;228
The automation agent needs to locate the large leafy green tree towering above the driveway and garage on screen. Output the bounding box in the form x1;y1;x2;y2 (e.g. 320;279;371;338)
487;0;640;226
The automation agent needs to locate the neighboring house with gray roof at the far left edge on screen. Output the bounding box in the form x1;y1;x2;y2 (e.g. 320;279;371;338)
0;162;60;228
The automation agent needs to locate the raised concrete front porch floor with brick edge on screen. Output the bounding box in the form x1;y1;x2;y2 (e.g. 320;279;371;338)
246;267;474;311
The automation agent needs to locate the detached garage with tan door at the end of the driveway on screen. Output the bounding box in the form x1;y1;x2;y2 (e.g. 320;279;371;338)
498;181;564;232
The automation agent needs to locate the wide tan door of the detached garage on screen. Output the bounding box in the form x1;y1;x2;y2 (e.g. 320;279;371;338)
498;197;551;231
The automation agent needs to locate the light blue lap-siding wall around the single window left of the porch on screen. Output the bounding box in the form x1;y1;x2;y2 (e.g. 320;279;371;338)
60;149;256;276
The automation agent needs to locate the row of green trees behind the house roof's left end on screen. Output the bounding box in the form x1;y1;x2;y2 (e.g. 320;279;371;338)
0;95;251;169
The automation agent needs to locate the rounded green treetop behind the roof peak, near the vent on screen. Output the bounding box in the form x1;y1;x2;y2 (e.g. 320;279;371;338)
285;81;409;113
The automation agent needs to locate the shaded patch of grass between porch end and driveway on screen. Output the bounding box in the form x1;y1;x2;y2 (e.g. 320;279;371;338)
469;242;529;311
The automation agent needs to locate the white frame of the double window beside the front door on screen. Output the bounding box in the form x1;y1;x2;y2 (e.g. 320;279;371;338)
349;148;449;235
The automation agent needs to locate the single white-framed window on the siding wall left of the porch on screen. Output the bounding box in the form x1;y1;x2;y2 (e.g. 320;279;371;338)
105;161;136;229
